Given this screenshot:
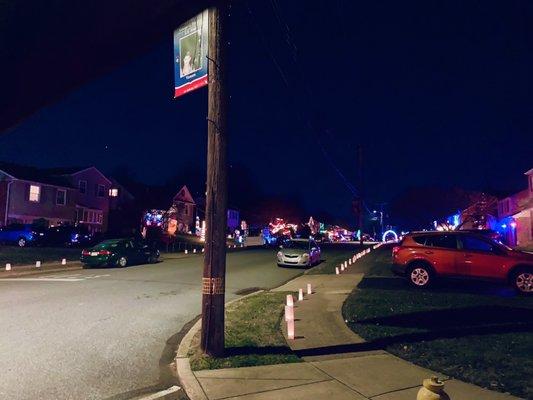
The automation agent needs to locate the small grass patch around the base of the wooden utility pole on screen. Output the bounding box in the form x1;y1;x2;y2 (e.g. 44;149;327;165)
189;292;301;371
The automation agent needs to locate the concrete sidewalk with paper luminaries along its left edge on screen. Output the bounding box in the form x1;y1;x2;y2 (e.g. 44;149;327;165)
179;252;517;400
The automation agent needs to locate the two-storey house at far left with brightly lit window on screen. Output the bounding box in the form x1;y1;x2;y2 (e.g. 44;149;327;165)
0;163;116;232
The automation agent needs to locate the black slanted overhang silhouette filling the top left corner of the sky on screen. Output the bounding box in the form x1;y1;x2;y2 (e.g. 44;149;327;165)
0;0;220;132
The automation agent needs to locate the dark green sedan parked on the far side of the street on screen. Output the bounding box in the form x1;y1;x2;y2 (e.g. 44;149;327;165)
81;238;159;267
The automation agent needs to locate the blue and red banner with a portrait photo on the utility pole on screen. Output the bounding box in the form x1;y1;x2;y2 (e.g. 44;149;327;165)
174;10;209;98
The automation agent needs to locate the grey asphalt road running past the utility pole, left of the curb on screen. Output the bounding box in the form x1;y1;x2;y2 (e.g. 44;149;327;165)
0;249;302;400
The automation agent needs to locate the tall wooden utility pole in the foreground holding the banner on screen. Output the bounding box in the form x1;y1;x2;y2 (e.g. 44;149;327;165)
201;6;227;356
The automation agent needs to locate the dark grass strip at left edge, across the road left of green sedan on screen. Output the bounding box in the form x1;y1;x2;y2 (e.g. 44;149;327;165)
0;246;81;266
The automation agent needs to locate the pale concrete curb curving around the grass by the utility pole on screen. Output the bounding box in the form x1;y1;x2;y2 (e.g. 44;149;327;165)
174;290;264;400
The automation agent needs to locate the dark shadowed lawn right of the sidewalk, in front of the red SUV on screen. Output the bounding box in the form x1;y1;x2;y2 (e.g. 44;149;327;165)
343;251;533;399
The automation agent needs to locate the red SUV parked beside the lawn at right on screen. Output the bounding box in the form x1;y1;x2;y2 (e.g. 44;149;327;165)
392;231;533;295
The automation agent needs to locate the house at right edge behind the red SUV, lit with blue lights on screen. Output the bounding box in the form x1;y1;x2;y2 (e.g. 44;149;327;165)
498;168;533;247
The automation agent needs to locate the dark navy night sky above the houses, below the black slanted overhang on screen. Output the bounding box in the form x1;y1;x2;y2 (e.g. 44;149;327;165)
0;0;533;222
